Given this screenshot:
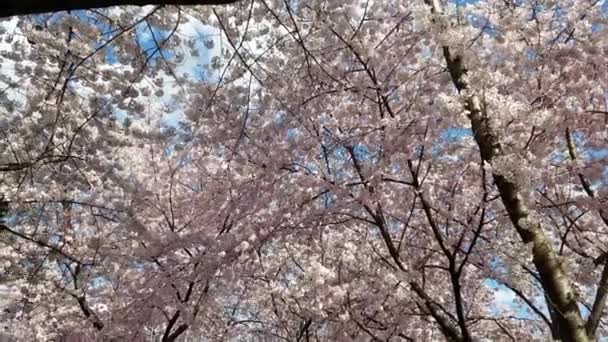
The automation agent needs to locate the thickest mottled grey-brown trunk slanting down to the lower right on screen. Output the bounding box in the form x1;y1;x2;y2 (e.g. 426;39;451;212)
425;0;589;342
